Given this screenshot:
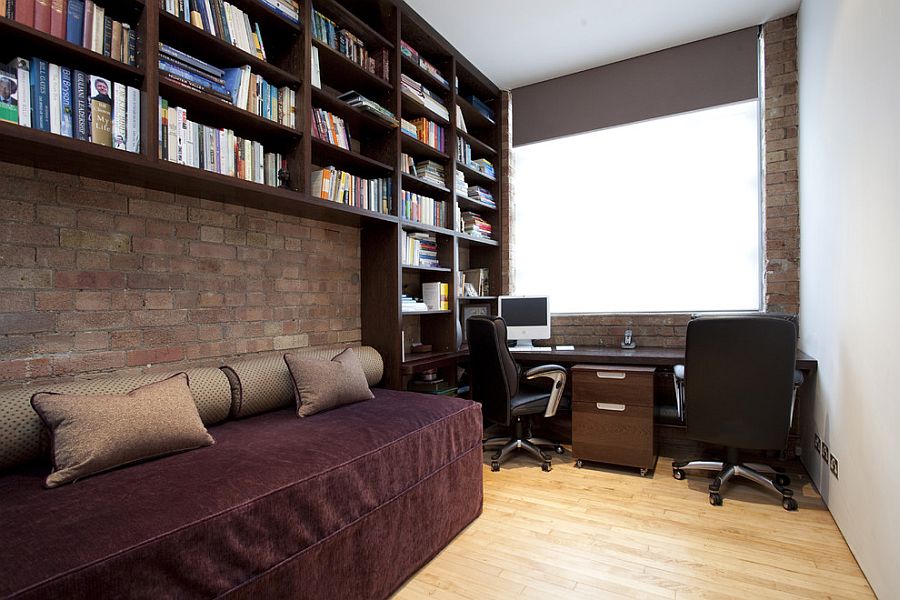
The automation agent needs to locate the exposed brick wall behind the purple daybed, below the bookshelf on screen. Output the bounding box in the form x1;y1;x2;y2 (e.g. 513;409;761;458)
0;163;361;385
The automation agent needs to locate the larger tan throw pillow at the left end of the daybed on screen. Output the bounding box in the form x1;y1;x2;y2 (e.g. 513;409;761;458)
31;373;214;488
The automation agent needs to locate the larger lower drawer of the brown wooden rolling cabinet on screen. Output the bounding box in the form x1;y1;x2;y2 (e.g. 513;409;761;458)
572;402;656;469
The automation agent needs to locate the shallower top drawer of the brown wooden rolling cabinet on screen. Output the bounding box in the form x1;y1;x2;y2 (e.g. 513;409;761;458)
572;365;656;407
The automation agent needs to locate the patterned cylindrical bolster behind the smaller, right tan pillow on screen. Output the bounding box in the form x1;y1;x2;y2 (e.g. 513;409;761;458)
222;346;384;418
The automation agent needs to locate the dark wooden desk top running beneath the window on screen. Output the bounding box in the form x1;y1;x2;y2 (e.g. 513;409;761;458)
402;346;818;374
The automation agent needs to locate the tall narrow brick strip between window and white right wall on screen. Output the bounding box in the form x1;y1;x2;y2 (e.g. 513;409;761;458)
763;15;800;313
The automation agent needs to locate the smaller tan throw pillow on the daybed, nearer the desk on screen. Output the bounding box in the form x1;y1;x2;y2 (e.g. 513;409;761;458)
284;348;375;417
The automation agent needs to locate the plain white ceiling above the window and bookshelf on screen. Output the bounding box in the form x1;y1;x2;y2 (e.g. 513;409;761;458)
406;0;800;89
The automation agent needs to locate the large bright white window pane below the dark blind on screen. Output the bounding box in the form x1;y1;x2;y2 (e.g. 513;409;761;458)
514;100;762;313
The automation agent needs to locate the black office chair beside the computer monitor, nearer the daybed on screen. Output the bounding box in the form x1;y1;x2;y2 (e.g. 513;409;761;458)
466;315;566;471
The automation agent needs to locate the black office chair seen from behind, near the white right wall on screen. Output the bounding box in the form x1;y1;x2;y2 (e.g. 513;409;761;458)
672;315;802;510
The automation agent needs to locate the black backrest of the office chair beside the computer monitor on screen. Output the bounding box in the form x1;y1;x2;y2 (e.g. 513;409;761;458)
466;315;519;425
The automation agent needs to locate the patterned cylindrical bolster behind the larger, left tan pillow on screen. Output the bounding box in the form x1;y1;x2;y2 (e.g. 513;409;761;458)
0;368;231;470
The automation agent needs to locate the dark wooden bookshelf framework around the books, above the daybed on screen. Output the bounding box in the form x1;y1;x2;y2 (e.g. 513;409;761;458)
0;0;506;388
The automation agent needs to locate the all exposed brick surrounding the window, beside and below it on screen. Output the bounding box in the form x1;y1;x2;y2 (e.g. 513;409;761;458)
504;15;800;348
